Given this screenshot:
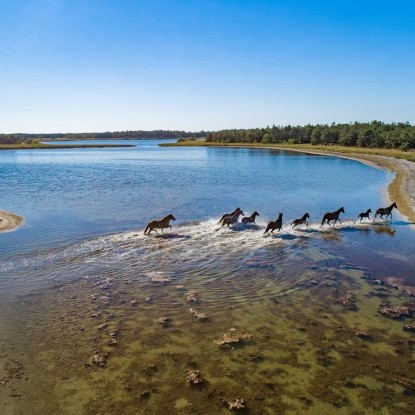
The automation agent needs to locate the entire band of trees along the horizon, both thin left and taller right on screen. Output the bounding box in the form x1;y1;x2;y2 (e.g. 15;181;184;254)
0;121;415;151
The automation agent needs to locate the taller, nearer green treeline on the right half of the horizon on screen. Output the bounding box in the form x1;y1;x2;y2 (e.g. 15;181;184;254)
206;121;415;150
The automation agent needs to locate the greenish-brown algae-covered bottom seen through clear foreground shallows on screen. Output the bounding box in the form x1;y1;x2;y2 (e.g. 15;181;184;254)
5;245;415;415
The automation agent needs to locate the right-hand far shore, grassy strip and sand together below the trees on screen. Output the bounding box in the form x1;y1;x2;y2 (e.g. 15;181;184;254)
160;140;415;223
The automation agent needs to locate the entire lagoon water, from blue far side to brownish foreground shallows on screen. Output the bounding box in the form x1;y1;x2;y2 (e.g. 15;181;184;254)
0;140;415;414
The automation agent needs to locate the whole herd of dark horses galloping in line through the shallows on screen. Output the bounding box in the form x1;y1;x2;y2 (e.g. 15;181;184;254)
144;202;398;235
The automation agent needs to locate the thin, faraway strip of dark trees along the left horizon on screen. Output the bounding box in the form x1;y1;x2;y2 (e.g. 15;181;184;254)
0;130;207;144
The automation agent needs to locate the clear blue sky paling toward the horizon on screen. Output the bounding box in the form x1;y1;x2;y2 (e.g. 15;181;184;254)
0;0;415;133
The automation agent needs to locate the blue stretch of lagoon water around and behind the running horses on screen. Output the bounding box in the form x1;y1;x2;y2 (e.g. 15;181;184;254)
0;140;415;294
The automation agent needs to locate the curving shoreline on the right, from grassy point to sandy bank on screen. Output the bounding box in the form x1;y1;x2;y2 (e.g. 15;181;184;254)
162;142;415;223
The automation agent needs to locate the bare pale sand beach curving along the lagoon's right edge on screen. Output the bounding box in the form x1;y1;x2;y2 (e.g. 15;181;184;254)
264;147;415;223
